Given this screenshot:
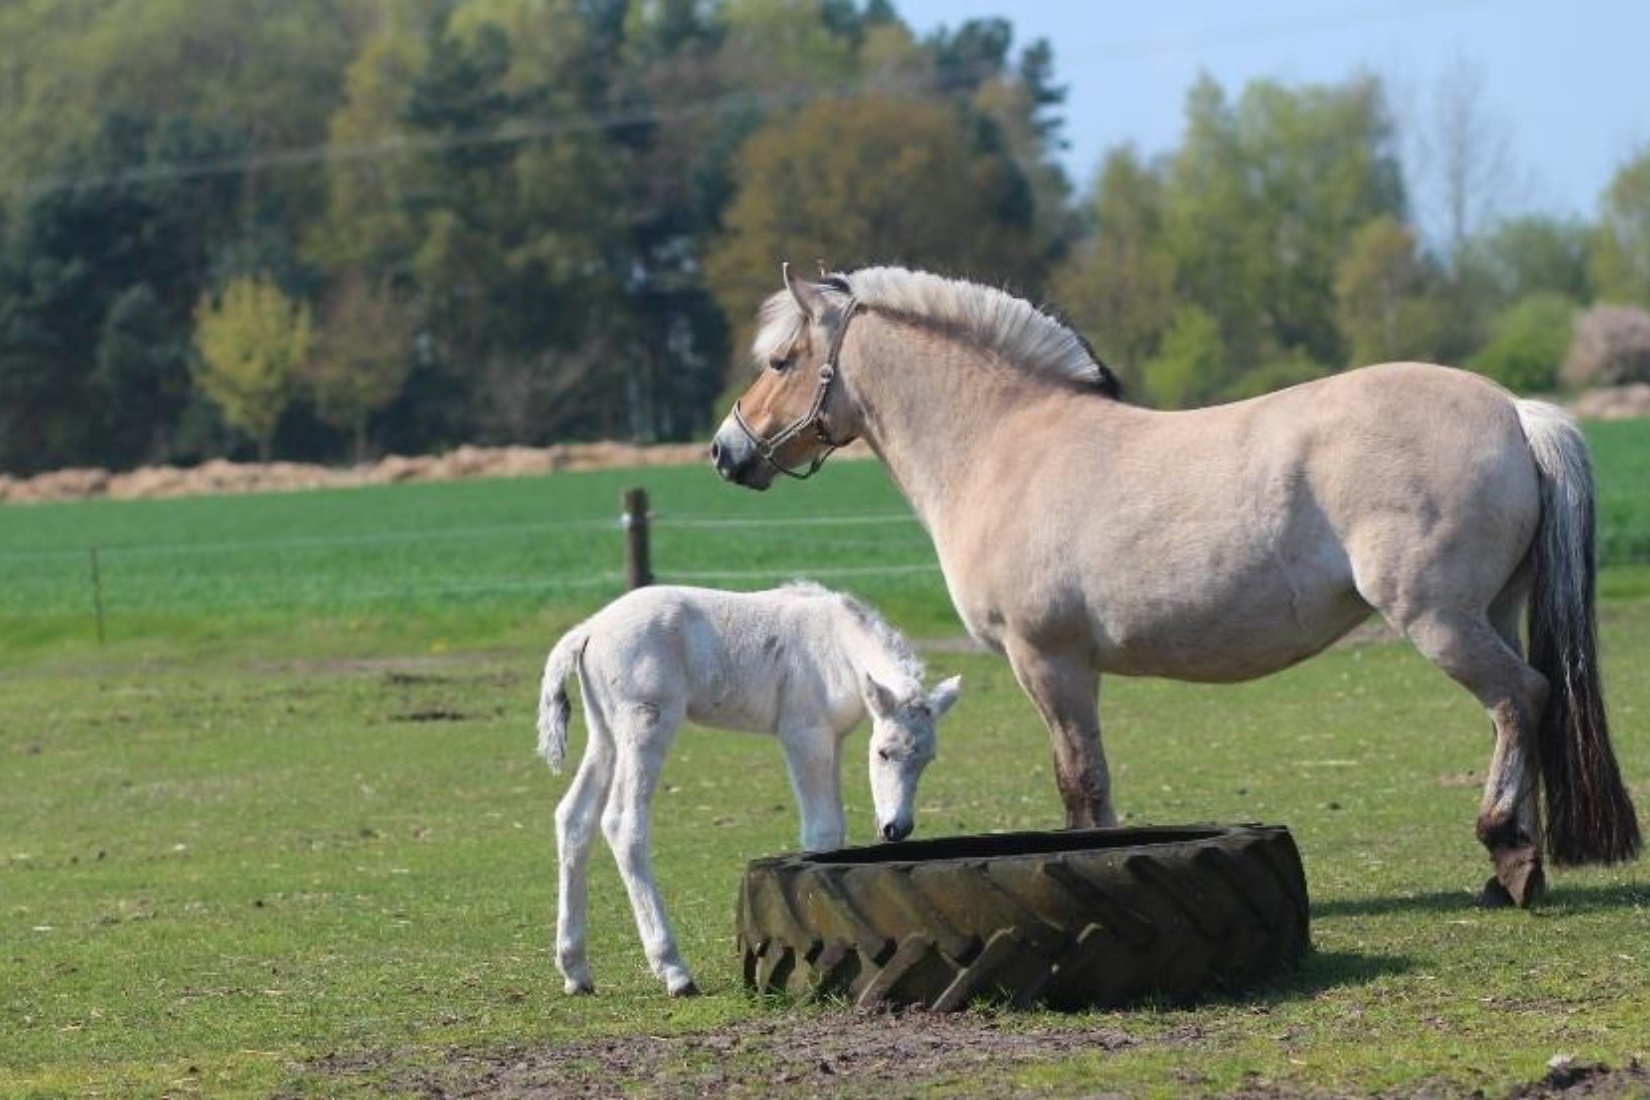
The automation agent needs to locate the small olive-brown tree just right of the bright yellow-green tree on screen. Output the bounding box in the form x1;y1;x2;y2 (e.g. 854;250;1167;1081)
297;272;419;462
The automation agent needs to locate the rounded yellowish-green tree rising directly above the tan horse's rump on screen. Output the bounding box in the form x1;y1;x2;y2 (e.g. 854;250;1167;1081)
1335;216;1442;366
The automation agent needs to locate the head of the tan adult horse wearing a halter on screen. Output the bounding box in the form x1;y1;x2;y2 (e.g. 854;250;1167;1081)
711;264;856;490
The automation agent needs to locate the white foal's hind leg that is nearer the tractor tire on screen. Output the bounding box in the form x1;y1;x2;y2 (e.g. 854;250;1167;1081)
602;704;698;996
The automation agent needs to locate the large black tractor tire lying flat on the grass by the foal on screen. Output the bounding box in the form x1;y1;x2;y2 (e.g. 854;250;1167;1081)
738;825;1310;1011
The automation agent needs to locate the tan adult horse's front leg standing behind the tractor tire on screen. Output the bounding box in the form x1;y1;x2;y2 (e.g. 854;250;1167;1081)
1007;642;1117;828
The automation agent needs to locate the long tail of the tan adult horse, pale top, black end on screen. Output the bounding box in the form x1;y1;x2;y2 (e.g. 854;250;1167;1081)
1518;401;1640;864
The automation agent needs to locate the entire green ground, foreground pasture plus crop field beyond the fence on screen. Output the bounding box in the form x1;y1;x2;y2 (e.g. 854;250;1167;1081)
0;425;1650;1097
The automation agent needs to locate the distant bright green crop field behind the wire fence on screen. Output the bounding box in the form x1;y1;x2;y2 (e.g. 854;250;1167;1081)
0;422;1650;650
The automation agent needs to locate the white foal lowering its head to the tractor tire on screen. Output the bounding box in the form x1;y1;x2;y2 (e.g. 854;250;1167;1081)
538;584;960;996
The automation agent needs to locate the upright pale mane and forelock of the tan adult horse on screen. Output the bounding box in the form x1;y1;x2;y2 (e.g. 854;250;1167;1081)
752;267;1122;397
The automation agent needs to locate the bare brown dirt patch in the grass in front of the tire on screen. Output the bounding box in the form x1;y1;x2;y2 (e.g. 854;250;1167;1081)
287;1011;1161;1100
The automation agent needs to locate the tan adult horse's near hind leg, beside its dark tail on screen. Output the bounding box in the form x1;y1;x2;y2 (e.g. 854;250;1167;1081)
1404;606;1548;905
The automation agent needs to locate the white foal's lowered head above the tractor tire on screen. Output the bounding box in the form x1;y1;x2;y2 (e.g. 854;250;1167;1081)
863;675;962;841
